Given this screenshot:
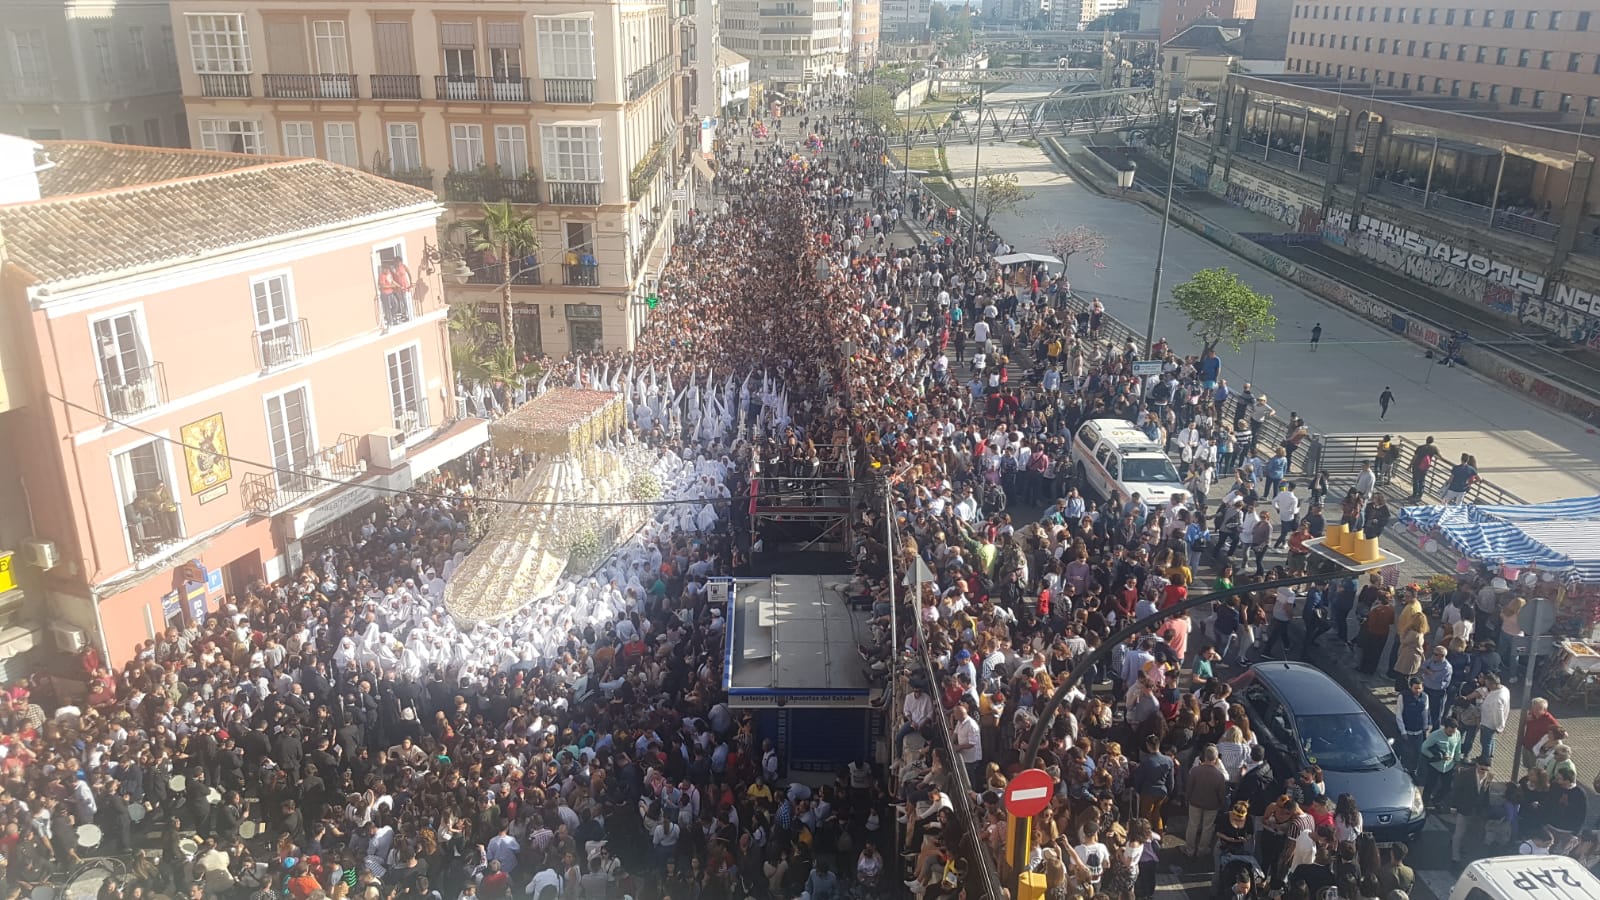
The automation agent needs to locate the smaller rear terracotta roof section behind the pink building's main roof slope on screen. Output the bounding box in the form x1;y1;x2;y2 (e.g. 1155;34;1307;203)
38;141;272;197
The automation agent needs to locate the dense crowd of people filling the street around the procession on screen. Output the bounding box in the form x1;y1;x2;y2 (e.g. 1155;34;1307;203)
0;84;1600;900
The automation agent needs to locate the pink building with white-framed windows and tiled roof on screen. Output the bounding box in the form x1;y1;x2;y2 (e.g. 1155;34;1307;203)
0;138;486;663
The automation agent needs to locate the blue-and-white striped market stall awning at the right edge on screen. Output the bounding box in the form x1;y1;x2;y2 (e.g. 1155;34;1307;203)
1400;496;1600;585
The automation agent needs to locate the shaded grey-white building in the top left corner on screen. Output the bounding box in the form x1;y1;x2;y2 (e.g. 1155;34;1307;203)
0;0;189;147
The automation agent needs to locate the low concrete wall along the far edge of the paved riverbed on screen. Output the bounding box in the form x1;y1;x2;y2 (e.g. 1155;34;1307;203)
1045;138;1600;423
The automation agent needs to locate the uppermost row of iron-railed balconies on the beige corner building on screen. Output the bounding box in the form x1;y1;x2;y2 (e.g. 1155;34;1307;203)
200;71;598;104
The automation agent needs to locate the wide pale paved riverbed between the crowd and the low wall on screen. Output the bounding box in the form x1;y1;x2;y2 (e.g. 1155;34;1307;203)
947;124;1600;501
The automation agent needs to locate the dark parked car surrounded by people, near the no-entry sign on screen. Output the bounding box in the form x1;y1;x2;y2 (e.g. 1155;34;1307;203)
1234;661;1427;844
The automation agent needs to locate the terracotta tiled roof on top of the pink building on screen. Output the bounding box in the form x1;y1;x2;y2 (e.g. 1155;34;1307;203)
0;143;435;285
